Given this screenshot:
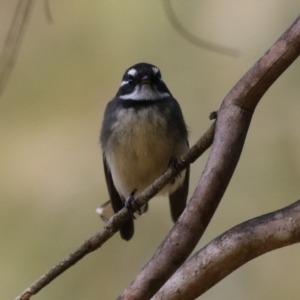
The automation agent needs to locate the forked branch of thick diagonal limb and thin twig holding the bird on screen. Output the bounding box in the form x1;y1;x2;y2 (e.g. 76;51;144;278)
17;13;300;300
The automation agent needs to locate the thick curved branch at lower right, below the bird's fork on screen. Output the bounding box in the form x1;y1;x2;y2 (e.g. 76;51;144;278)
152;200;300;300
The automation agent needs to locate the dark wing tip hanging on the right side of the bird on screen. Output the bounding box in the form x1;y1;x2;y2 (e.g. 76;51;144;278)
169;166;190;223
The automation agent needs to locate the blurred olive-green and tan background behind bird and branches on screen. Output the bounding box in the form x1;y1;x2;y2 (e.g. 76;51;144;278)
0;0;300;300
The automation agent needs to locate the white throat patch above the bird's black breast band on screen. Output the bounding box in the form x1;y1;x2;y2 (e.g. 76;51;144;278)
120;84;170;100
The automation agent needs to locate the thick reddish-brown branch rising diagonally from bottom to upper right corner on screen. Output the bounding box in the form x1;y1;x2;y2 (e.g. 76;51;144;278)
118;18;300;300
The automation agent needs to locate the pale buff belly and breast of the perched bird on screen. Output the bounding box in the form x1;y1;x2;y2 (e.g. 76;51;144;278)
105;108;188;198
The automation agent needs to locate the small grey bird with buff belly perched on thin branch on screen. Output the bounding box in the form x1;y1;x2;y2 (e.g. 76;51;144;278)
100;63;190;241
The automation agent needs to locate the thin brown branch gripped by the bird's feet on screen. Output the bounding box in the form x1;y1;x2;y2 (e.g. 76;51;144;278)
16;123;215;300
